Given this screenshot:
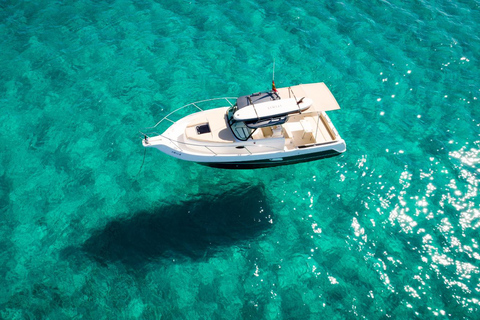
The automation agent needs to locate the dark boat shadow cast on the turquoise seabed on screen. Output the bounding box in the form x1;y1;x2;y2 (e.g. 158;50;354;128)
74;184;273;268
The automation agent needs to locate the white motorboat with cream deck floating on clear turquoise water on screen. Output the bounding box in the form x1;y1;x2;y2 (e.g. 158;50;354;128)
141;82;346;169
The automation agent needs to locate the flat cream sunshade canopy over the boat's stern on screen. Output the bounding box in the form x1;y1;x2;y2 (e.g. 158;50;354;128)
277;82;340;112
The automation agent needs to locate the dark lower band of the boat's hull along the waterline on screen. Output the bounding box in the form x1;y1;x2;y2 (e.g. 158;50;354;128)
198;150;341;169
